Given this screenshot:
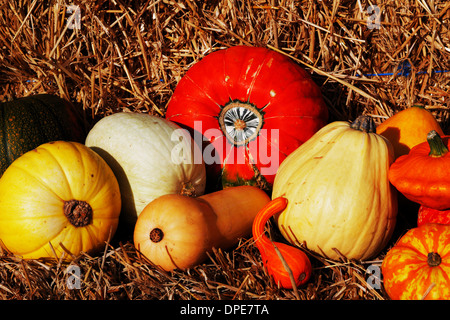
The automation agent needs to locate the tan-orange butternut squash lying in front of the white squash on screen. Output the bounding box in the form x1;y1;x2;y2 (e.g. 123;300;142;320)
134;186;270;271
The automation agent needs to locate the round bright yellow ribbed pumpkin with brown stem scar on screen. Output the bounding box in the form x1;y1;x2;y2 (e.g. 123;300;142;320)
0;141;121;258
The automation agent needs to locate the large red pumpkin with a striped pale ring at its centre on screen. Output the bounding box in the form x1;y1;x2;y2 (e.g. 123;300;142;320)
166;46;328;189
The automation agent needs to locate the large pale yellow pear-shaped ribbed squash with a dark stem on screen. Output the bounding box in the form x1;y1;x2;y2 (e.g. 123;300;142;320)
272;116;397;260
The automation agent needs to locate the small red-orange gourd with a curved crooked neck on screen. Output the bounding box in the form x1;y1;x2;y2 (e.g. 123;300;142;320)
252;197;312;289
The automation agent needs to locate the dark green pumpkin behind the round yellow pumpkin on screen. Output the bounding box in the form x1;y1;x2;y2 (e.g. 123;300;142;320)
0;94;85;176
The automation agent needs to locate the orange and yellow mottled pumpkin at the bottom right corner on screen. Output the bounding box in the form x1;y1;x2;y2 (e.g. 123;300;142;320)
381;224;450;300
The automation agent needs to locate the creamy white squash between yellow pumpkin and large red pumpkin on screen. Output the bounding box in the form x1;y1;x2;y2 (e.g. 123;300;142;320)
86;112;206;223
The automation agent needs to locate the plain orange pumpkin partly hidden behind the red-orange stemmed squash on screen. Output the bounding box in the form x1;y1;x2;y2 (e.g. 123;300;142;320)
377;105;444;158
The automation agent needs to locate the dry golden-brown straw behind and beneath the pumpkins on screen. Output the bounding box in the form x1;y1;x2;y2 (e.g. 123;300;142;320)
0;0;450;300
